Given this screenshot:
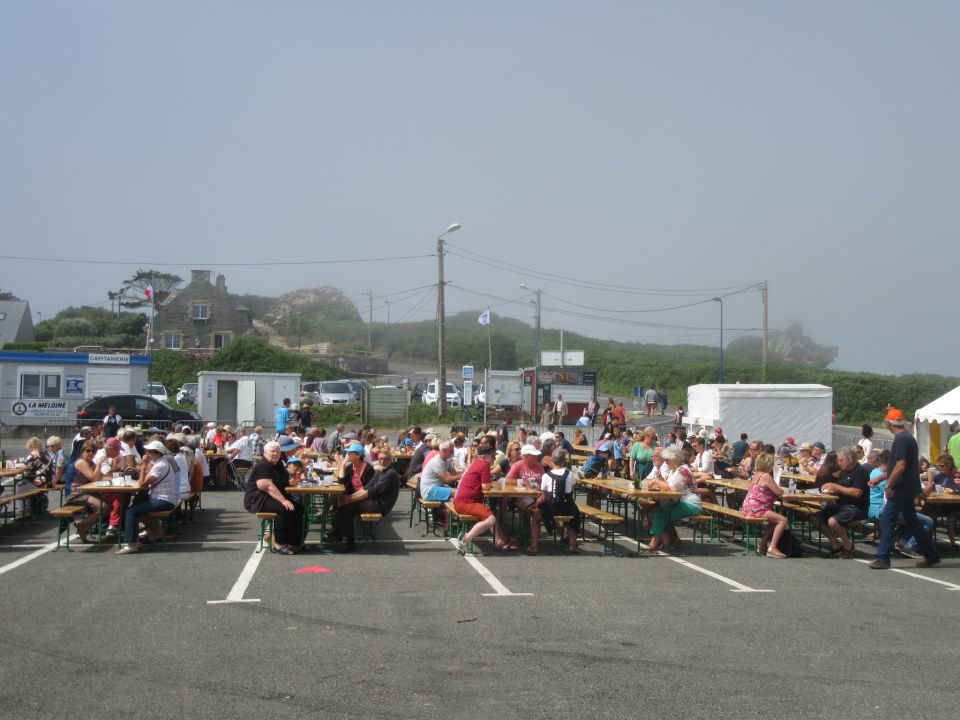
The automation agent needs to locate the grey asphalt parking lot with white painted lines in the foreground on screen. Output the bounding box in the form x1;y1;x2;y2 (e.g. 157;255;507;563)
0;492;960;720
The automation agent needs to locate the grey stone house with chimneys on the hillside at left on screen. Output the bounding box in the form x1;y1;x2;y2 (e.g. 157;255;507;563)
153;270;256;350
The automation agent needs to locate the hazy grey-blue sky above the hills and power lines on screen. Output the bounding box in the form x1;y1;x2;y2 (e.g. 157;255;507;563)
0;0;960;374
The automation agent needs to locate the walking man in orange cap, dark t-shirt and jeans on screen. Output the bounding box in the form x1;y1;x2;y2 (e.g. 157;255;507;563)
869;407;941;570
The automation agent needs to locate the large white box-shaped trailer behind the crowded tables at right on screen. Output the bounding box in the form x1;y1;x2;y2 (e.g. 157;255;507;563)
684;385;833;449
